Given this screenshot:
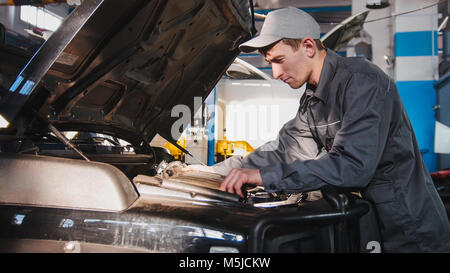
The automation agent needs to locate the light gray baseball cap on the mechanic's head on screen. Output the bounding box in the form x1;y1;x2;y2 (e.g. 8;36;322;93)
239;7;320;52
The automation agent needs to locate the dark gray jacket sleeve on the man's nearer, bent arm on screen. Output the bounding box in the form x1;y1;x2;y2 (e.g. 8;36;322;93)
260;73;393;192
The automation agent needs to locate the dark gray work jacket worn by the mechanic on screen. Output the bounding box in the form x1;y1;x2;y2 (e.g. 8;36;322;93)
214;50;450;252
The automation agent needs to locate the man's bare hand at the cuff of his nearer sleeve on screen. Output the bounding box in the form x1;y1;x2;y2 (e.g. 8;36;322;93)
220;169;263;198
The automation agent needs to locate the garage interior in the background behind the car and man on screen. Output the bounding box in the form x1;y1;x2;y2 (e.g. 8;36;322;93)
0;0;450;253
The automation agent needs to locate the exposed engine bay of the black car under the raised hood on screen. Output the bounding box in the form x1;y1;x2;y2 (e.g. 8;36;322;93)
0;132;321;208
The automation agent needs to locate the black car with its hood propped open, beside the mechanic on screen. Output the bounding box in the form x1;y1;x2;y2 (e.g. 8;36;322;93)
0;0;381;253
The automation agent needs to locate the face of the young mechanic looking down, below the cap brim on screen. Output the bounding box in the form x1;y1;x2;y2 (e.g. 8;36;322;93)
265;41;311;89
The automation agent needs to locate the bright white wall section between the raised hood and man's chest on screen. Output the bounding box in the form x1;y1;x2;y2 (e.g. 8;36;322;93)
215;79;305;148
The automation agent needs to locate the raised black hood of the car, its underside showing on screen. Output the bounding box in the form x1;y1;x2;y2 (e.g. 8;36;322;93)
0;0;255;142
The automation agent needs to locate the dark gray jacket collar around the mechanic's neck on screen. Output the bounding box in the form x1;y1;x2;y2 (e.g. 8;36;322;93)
306;48;340;103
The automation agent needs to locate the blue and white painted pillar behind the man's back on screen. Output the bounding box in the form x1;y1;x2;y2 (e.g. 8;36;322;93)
394;0;439;172
